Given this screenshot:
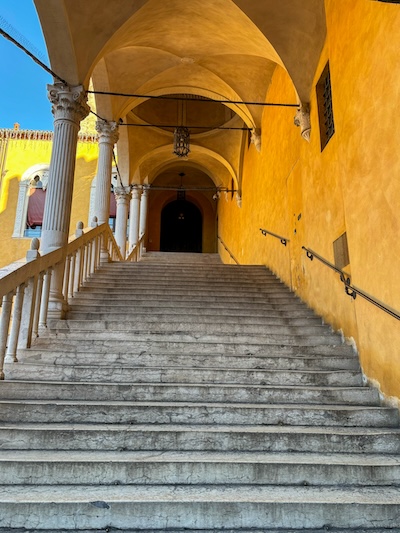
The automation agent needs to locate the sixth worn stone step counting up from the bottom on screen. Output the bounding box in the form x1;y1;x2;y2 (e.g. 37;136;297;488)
4;362;362;387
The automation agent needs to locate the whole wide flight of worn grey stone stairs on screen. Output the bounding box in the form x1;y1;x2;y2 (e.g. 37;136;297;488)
0;254;400;533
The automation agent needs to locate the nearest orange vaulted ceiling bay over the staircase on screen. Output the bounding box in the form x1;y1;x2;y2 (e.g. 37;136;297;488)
35;0;325;187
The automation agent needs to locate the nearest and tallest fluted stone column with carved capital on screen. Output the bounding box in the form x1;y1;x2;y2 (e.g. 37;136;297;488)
42;83;89;318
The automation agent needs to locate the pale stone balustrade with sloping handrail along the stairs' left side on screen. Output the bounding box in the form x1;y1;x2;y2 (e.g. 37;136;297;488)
0;223;124;379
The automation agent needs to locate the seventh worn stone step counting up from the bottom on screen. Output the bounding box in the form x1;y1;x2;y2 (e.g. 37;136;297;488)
18;349;360;370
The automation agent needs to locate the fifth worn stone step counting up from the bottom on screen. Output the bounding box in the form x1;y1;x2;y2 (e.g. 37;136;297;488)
0;381;379;406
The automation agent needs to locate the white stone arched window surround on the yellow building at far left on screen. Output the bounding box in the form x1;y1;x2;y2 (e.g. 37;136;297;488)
12;163;50;239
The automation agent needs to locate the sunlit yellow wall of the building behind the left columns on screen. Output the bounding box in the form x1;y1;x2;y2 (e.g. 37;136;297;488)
0;139;98;268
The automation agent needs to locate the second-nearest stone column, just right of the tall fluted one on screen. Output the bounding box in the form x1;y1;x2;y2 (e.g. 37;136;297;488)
94;120;118;225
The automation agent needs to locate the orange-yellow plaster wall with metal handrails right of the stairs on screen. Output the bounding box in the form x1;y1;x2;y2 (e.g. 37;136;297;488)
219;0;400;398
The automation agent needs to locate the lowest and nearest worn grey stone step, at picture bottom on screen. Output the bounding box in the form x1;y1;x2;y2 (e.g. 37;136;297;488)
0;485;400;530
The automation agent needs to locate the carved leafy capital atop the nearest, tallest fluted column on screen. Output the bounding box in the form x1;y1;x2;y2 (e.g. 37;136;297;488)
47;83;90;125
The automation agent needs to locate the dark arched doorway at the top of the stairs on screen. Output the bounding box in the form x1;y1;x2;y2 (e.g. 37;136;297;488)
160;199;203;252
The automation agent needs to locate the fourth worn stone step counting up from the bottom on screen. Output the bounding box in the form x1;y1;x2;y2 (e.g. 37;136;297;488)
0;400;399;427
